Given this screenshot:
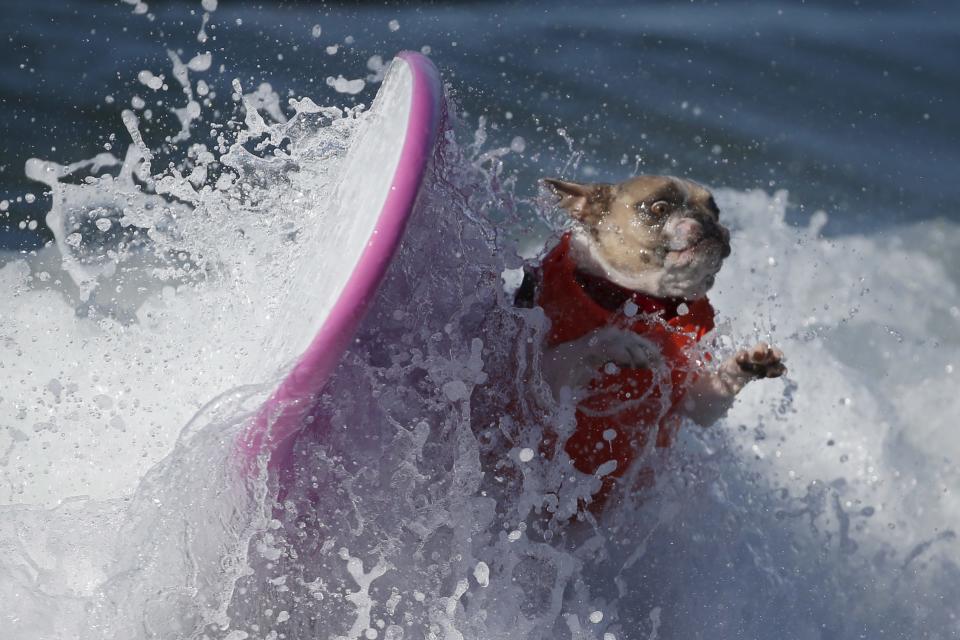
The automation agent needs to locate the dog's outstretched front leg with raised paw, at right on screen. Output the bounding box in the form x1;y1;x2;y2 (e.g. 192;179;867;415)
684;342;787;427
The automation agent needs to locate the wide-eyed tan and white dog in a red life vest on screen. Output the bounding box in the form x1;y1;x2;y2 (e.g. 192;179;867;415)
514;175;787;504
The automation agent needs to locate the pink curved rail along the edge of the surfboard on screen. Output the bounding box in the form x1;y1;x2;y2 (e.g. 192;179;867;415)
237;51;443;473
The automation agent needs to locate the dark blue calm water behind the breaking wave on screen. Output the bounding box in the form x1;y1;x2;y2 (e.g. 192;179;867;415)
0;0;960;249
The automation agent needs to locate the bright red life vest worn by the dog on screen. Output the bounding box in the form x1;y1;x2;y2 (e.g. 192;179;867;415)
537;233;714;493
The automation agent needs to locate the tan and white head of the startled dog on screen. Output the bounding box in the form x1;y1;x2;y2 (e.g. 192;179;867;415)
545;176;730;300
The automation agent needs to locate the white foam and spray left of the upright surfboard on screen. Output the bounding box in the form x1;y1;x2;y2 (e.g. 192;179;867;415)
0;40;372;638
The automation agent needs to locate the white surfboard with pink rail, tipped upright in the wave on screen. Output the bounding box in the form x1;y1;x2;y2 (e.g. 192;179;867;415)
238;52;443;471
